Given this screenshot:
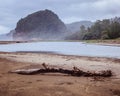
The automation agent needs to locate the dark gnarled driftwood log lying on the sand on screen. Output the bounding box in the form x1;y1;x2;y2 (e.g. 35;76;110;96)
10;63;112;77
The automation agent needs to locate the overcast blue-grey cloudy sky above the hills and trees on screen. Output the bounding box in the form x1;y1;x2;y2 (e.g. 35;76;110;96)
0;0;120;34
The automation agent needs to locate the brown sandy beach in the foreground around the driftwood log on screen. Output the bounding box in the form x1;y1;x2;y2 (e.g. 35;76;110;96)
0;52;120;96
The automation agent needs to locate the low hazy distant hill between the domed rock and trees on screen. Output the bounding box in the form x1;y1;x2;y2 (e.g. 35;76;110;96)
66;21;93;33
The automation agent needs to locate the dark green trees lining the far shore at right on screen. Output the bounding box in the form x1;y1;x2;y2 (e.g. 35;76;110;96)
67;19;120;40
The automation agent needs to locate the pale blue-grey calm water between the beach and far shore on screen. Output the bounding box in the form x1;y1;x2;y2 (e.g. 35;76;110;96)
0;42;120;58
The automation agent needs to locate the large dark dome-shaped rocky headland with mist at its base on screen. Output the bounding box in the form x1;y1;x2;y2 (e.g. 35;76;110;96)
13;10;66;40
